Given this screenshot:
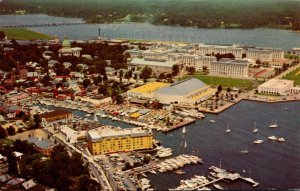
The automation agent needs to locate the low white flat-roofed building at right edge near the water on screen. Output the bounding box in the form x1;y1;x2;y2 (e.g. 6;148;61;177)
257;79;294;95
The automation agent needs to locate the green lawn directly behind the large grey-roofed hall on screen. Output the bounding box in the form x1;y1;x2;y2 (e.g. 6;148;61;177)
188;74;254;87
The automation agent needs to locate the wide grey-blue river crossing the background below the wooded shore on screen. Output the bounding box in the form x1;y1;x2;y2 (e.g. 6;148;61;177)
0;14;300;50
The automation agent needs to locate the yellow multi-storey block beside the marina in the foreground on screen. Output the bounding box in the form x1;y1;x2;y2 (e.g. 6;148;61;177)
87;128;153;155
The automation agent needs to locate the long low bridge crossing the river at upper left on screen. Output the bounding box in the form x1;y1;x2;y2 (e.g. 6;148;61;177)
0;22;89;29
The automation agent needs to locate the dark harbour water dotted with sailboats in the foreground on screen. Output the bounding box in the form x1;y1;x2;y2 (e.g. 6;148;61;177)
39;101;300;190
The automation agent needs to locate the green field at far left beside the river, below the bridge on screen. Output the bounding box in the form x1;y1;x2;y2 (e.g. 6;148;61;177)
1;29;53;40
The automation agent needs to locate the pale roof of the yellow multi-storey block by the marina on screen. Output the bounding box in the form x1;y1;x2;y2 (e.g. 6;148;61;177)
87;128;152;141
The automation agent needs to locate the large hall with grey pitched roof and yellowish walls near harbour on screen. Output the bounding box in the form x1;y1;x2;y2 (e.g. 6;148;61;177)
154;78;216;104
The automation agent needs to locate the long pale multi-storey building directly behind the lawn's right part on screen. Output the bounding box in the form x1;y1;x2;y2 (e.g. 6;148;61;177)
209;59;250;77
